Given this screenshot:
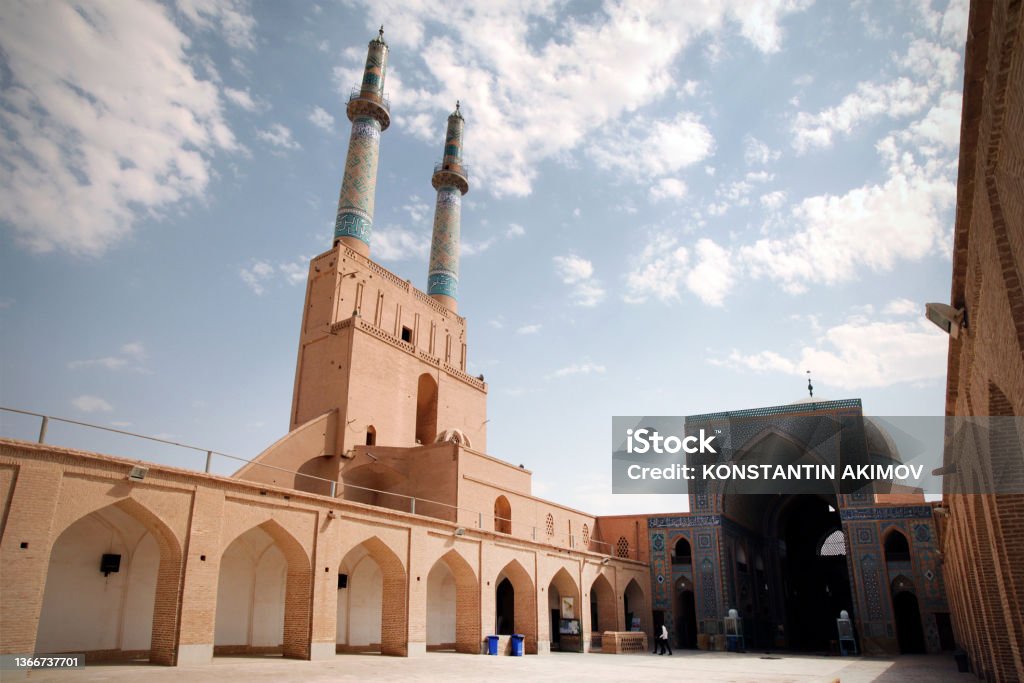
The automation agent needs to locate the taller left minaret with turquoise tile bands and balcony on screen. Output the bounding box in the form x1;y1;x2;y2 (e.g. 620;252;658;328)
334;26;391;256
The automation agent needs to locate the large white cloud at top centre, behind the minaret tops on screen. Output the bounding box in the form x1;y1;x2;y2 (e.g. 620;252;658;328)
339;0;807;196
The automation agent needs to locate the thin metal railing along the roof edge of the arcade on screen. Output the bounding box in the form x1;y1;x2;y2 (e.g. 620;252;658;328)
0;407;639;559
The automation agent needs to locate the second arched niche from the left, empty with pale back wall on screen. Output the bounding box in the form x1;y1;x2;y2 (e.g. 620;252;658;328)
213;520;311;659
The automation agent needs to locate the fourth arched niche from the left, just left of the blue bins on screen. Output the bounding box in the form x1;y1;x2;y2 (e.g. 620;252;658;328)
427;550;480;654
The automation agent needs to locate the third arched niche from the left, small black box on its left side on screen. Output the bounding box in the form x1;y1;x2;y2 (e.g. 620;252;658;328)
335;537;409;656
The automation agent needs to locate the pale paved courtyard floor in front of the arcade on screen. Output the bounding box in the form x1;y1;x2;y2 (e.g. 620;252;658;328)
9;651;977;683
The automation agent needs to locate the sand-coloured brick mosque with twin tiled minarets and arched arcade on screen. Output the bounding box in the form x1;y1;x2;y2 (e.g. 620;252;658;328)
0;2;1024;680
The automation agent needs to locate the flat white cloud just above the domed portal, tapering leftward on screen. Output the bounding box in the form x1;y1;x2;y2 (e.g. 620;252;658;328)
711;316;948;390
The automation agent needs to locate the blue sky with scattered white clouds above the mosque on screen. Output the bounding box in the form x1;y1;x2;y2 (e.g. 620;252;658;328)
0;0;967;514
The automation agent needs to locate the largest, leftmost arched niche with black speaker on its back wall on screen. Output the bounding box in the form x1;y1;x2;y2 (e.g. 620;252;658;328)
35;499;181;665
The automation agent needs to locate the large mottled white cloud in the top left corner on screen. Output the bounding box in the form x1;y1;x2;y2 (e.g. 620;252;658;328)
0;0;239;256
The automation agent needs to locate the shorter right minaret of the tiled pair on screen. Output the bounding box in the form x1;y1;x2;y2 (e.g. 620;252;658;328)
427;102;469;312
